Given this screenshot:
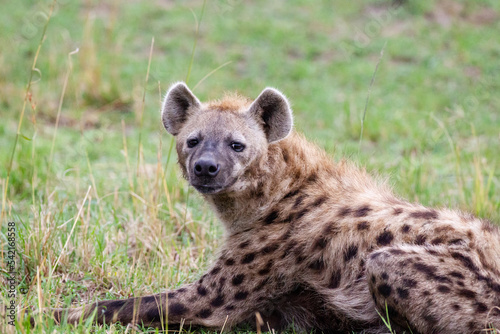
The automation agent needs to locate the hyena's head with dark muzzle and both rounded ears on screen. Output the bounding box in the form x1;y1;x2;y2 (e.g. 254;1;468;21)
161;82;292;194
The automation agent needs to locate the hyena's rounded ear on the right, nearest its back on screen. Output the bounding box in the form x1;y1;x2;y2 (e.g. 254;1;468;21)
248;88;293;143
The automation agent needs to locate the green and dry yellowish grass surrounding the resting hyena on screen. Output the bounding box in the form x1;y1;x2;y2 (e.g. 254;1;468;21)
0;0;500;333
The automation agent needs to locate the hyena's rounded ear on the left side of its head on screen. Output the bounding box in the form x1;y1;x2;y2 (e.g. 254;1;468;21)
161;82;201;136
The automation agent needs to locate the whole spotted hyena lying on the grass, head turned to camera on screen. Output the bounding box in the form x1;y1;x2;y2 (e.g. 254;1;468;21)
45;83;500;333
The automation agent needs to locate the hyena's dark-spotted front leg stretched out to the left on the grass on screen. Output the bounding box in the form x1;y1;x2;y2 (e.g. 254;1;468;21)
54;250;289;328
